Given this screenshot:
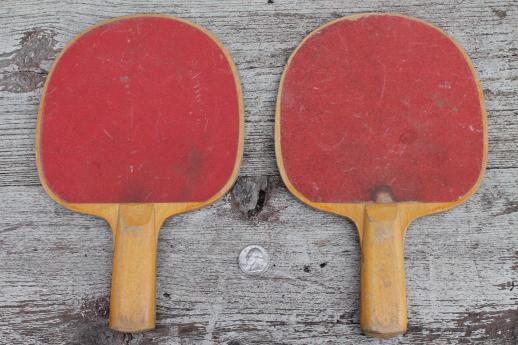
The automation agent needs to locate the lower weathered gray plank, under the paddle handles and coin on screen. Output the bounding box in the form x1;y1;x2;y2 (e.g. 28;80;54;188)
0;169;518;344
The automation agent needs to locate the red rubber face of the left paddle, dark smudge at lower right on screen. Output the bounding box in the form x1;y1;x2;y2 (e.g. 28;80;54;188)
40;16;240;203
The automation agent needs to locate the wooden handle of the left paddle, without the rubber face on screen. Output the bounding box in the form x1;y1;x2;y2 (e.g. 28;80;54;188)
110;204;158;332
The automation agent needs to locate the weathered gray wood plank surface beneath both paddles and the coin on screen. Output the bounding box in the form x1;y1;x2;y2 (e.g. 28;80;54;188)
0;0;518;345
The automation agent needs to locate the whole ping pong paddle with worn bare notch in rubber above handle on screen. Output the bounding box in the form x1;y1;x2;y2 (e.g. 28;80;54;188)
275;14;487;337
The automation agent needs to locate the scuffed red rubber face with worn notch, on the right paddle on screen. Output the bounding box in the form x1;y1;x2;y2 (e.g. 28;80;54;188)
280;15;484;202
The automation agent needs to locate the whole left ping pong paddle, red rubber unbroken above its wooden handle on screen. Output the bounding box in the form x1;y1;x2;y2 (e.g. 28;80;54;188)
37;15;243;332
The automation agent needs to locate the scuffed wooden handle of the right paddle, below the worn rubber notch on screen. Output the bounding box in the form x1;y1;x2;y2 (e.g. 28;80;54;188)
360;204;407;338
